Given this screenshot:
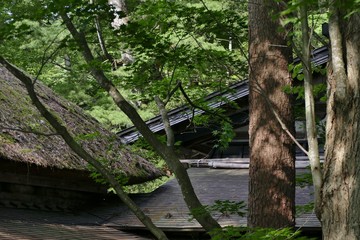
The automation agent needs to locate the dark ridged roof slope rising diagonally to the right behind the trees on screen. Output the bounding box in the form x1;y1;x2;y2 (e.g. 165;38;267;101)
118;46;329;143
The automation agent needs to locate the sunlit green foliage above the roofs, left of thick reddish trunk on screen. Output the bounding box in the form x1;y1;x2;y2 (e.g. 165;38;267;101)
0;0;247;135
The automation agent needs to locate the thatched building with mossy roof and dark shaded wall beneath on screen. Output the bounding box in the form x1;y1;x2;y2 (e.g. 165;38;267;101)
0;65;162;210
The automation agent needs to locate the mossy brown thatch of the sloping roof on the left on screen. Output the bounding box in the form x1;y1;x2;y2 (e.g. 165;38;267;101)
0;65;161;184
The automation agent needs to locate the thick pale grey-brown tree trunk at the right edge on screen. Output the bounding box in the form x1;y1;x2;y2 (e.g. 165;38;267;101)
321;5;360;240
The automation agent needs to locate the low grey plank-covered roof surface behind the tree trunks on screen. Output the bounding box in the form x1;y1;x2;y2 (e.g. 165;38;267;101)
105;168;320;231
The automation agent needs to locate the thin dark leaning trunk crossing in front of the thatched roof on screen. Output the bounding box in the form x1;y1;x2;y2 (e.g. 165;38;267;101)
0;56;167;240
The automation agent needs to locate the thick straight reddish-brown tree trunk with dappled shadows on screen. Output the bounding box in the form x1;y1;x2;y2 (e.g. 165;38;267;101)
248;0;295;228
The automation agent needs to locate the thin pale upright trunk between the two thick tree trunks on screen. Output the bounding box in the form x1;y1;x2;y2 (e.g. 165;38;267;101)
300;3;322;219
